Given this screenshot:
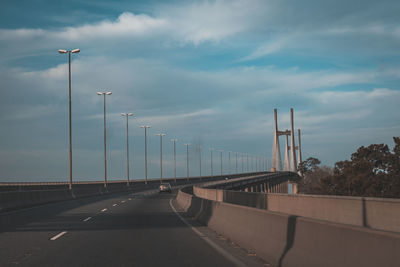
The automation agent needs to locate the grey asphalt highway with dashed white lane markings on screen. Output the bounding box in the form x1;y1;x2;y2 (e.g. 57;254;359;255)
0;190;269;267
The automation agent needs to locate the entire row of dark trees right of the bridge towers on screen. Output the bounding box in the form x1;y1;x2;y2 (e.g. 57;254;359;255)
299;137;400;198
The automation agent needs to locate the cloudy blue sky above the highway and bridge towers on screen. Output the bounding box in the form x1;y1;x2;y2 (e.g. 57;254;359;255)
0;0;400;182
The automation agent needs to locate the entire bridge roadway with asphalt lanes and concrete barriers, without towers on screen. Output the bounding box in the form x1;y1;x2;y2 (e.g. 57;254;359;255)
0;172;400;266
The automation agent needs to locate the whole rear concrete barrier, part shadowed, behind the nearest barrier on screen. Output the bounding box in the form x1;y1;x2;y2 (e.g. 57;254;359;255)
193;186;400;233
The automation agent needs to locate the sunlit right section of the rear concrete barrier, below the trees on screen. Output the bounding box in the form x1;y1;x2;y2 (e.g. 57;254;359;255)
266;194;400;233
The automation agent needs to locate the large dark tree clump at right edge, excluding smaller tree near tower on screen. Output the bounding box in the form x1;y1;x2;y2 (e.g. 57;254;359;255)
321;137;400;197
